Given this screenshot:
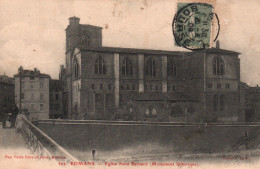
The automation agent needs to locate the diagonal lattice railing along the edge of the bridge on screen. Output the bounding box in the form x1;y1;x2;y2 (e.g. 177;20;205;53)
21;117;78;163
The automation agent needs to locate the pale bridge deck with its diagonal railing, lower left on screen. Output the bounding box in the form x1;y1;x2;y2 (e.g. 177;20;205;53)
0;116;78;168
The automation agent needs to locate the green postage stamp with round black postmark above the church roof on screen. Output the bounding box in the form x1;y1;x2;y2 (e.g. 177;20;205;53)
172;3;220;50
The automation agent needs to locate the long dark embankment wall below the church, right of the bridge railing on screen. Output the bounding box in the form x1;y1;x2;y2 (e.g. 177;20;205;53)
38;120;260;160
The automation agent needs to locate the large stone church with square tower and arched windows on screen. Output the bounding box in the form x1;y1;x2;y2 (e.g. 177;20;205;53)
65;17;244;122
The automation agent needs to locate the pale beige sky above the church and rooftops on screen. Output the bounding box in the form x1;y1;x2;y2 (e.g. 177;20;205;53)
0;0;260;86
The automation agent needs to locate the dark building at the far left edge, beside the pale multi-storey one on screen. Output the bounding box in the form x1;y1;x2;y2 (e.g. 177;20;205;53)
0;75;15;121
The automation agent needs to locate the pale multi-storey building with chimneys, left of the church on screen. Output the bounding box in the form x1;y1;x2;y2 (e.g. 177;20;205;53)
14;67;50;120
